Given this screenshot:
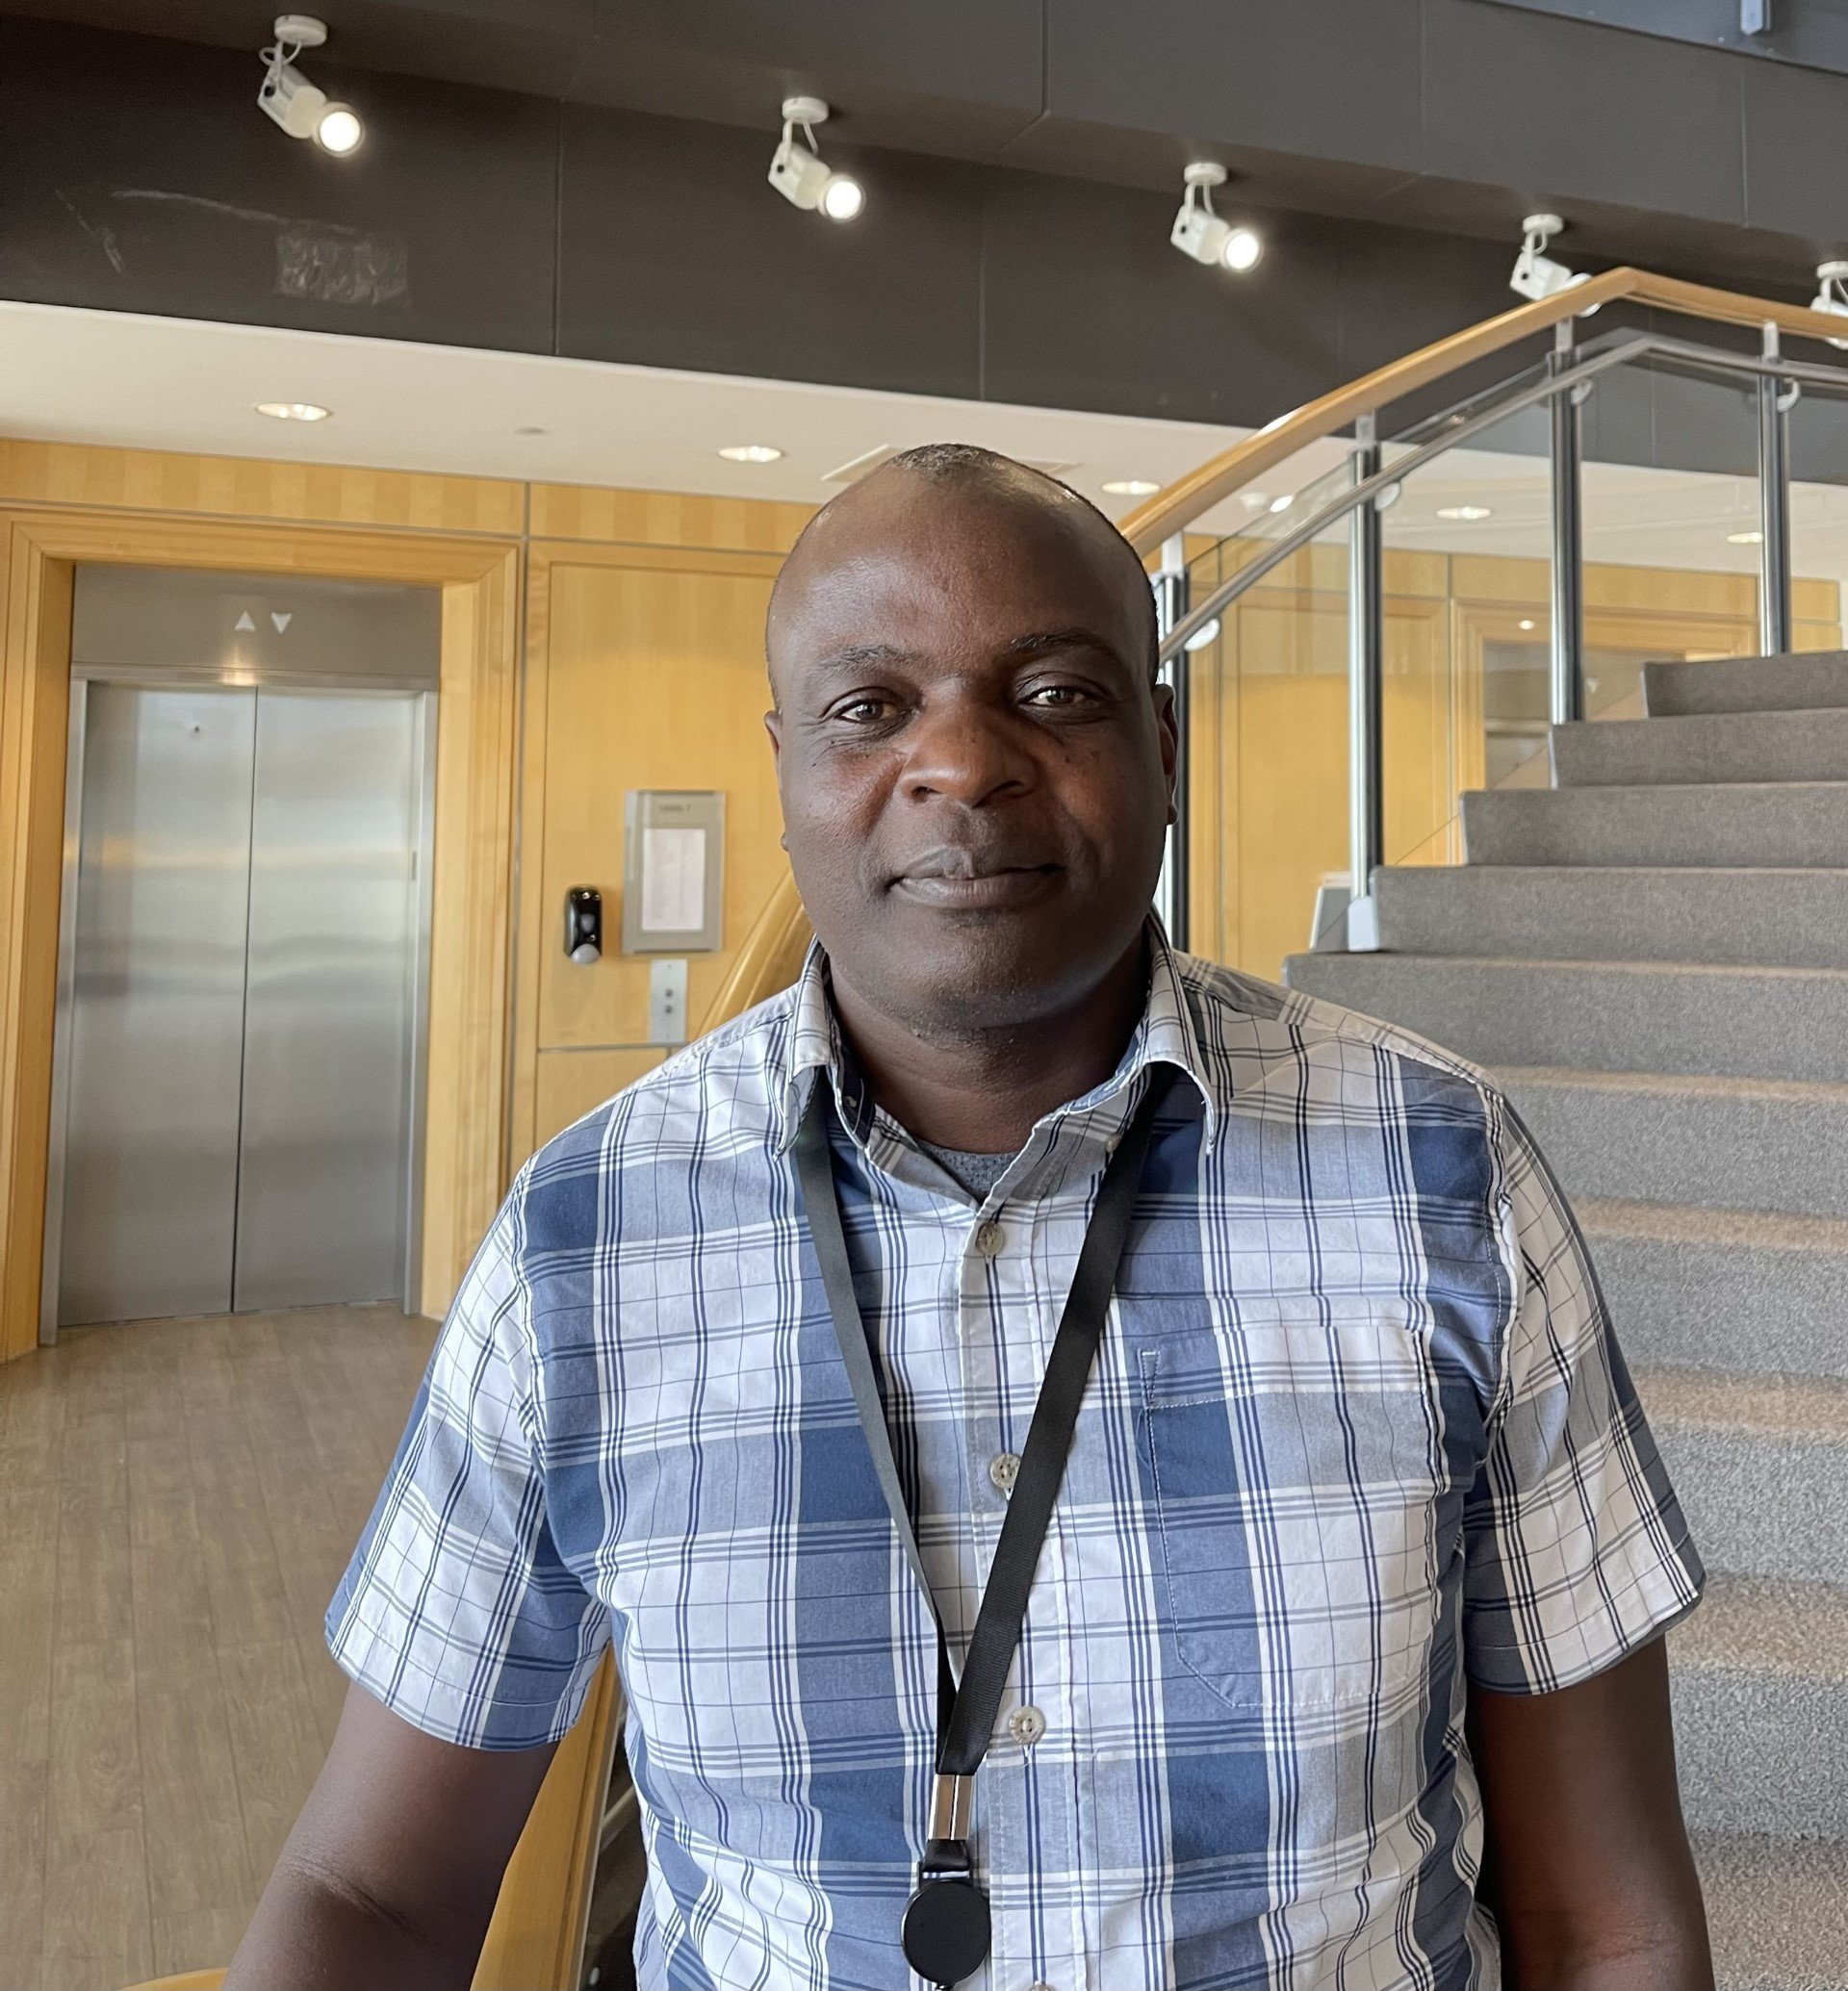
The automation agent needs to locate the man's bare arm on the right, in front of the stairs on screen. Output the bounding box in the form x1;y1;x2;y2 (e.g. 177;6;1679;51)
1470;1639;1712;1991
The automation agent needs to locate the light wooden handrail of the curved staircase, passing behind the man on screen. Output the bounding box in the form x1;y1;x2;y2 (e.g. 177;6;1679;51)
138;267;1842;1991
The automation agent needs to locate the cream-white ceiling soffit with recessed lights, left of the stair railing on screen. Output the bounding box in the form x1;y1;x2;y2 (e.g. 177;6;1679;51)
0;302;1246;518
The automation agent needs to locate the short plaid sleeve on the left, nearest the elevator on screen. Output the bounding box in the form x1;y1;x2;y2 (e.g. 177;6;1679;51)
326;1185;609;1750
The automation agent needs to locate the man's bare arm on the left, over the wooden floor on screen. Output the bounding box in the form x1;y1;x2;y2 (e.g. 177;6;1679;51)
225;1686;552;1991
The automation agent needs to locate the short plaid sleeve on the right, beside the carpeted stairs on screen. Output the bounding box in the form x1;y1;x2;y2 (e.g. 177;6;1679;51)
1464;1099;1705;1695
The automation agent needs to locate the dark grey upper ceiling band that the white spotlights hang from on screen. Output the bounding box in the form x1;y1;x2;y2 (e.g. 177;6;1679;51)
3;0;1848;285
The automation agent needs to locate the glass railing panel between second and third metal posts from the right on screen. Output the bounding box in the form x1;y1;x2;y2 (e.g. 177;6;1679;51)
1380;406;1553;864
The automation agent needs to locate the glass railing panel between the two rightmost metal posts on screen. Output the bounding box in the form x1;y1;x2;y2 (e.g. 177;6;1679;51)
1583;365;1760;701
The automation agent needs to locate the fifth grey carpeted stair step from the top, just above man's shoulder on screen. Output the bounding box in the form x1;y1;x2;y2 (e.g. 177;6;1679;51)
1284;954;1848;1085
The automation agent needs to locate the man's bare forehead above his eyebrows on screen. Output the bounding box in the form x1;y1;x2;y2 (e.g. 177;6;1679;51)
769;480;1149;665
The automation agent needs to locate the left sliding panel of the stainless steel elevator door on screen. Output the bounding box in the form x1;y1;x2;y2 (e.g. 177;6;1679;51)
58;683;257;1326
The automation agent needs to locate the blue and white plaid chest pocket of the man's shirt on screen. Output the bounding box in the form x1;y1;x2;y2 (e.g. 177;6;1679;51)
1135;1308;1444;1708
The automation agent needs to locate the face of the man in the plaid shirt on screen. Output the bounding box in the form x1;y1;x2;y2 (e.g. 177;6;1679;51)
769;473;1175;1032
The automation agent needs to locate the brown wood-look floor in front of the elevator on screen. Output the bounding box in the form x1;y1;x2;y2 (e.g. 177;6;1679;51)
0;1308;436;1991
